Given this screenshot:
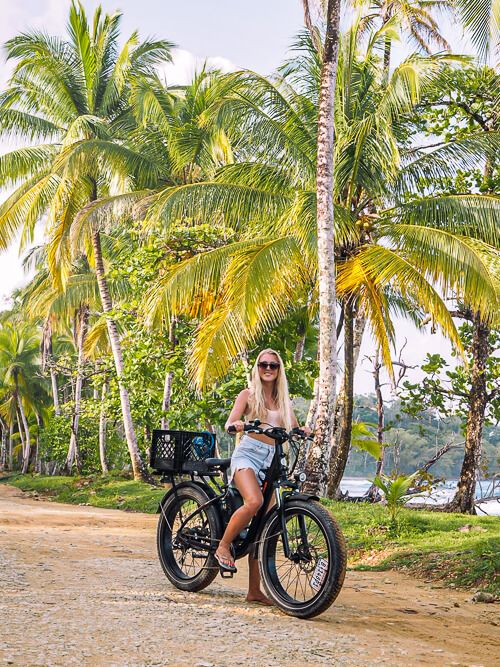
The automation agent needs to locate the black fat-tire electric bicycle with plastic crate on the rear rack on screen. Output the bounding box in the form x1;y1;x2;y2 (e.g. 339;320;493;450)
151;420;347;618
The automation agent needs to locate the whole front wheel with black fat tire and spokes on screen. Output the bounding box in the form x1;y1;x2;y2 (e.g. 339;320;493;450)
259;499;347;618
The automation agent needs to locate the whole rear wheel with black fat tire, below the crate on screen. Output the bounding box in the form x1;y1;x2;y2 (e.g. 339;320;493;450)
157;485;222;592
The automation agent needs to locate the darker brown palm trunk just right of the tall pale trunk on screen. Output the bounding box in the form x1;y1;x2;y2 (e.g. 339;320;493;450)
327;307;366;498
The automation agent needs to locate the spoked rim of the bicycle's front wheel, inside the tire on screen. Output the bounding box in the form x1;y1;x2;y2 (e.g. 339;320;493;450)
266;509;332;606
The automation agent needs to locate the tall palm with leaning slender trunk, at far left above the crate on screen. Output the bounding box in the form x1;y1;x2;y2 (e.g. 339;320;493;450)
0;3;171;478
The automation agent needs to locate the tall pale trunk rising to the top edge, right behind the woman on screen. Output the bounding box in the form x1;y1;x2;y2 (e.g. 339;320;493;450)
304;0;341;493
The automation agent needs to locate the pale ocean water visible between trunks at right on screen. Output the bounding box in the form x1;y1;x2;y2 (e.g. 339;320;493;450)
340;477;500;516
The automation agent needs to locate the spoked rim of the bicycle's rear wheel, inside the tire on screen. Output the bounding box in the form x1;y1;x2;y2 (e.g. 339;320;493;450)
163;498;212;580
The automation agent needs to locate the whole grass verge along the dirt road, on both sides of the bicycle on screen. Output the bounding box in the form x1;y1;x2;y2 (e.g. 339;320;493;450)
0;473;500;596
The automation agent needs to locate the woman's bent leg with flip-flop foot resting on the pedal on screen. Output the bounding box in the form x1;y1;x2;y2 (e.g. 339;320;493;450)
216;468;263;563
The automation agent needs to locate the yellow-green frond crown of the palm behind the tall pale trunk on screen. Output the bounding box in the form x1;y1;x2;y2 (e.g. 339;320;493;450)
135;30;498;496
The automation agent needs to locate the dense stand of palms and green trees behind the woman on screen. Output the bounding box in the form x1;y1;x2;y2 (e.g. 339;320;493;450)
0;0;500;520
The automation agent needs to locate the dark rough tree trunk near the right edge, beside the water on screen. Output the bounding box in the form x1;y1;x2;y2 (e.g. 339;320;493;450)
447;313;492;514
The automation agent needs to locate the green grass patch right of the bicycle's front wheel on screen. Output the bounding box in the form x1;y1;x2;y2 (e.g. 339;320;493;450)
325;501;500;596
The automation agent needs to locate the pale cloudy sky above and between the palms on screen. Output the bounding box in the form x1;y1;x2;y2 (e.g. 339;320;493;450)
0;0;478;393
